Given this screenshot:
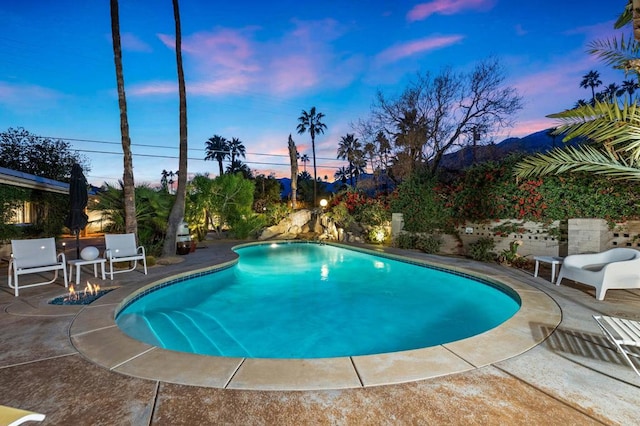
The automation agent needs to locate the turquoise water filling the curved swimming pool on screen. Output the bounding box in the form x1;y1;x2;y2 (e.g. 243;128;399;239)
116;243;520;358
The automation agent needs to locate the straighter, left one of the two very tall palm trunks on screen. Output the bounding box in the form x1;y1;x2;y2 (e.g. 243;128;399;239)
111;0;138;234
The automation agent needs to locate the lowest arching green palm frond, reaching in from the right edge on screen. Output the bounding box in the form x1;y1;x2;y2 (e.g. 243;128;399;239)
514;145;640;181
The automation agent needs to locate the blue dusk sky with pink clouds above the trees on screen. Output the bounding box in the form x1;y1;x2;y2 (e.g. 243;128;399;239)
0;0;626;185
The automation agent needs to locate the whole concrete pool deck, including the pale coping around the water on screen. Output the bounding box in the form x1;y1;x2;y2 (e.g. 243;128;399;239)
0;241;640;425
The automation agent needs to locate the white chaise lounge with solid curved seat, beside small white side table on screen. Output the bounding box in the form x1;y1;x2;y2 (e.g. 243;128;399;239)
556;247;640;300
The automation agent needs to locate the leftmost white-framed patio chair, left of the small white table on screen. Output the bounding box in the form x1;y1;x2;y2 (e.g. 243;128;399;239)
8;238;69;297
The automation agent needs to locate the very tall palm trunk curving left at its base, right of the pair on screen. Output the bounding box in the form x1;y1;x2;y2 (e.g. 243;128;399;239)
162;0;187;256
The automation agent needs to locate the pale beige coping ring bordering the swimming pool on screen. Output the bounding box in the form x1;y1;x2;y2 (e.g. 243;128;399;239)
63;241;562;391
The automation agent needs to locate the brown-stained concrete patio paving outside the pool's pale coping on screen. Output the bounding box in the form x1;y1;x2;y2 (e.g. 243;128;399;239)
0;241;640;425
